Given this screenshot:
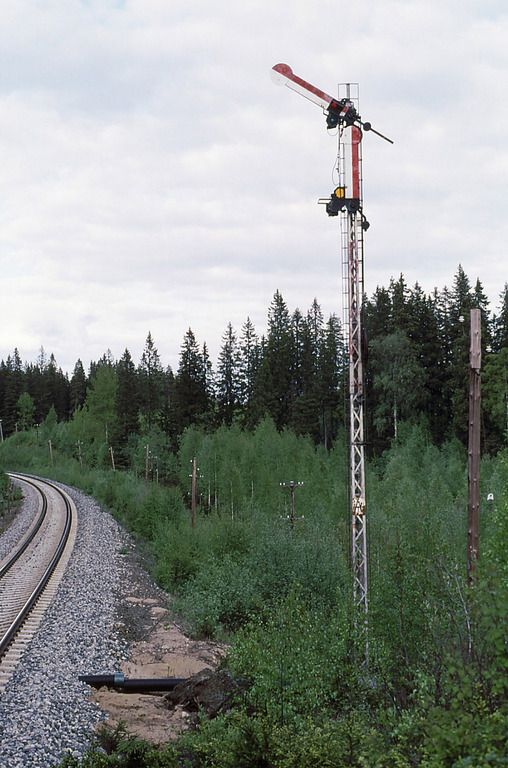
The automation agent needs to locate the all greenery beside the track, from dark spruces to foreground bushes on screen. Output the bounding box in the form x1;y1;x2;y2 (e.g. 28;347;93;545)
0;266;508;768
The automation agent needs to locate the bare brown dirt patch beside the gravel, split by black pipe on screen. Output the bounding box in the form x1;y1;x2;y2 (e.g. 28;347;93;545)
92;543;225;744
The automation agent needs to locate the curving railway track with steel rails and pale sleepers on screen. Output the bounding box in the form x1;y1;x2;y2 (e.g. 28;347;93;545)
0;473;77;694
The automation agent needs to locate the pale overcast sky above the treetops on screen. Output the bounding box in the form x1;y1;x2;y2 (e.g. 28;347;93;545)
0;0;508;373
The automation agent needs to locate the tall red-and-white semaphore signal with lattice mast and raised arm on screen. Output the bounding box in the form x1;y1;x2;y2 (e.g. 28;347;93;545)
272;64;393;629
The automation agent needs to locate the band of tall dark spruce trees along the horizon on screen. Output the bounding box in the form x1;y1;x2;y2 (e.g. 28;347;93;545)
0;265;508;467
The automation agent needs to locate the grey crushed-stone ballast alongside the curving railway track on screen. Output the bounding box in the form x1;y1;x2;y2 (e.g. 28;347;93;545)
0;483;133;768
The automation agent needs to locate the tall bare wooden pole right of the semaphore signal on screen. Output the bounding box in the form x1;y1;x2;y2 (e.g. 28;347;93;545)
467;309;482;584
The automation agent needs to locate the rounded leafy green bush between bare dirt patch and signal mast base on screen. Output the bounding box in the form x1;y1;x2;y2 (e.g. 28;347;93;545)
228;585;353;724
